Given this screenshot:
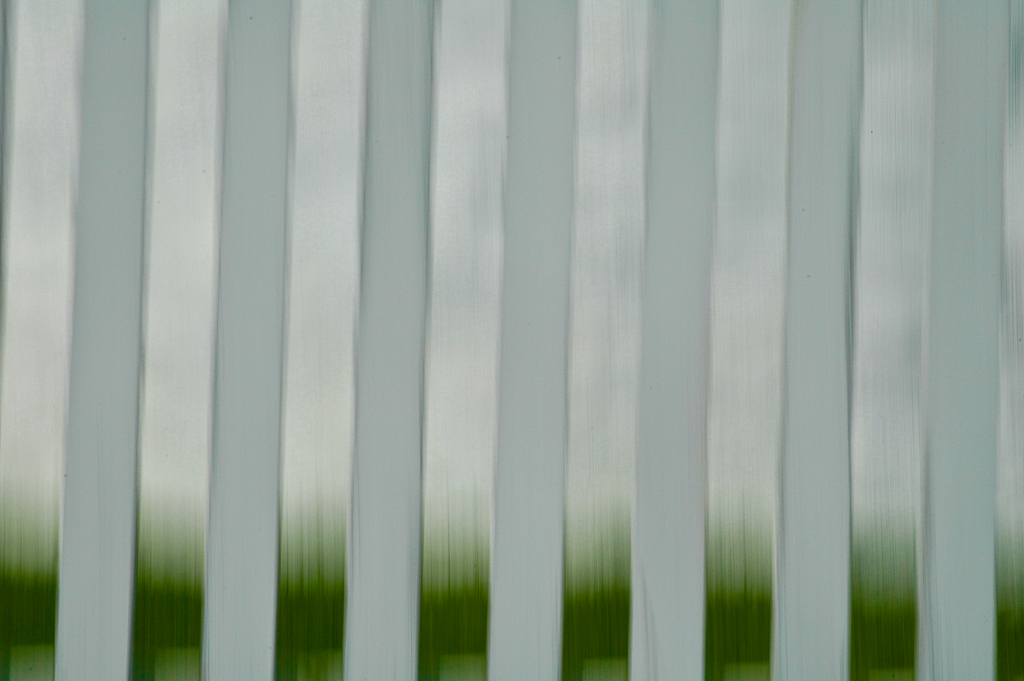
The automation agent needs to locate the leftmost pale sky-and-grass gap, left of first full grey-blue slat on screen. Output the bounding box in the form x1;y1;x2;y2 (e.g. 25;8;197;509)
0;0;82;679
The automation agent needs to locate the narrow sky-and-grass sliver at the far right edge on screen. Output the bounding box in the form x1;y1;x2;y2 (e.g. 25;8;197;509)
995;0;1024;681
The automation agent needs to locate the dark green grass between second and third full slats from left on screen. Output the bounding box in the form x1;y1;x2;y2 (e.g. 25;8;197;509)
274;578;345;681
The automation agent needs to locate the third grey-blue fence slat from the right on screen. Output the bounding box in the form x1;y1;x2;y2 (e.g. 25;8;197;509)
630;0;719;681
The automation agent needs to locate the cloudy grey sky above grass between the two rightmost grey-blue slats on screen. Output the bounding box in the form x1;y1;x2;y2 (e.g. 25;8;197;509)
851;0;934;535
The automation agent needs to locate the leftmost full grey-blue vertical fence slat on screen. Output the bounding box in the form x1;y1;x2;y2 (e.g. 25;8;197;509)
55;0;148;681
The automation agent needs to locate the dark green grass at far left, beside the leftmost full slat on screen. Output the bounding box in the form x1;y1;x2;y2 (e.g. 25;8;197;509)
0;569;57;681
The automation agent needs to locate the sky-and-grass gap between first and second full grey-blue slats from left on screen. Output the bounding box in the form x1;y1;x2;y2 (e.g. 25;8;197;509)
131;0;226;681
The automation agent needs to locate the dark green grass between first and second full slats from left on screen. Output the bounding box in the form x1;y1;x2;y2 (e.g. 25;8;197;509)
131;570;203;681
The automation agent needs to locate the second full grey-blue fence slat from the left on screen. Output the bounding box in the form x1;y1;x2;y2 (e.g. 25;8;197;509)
203;0;291;680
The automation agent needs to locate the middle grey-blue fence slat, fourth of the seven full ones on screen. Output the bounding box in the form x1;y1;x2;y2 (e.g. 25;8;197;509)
488;0;577;681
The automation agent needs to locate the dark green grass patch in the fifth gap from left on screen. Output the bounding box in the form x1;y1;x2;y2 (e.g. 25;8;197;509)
562;579;630;681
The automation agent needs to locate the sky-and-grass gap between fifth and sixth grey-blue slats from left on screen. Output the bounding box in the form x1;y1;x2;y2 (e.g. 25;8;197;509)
705;0;792;681
